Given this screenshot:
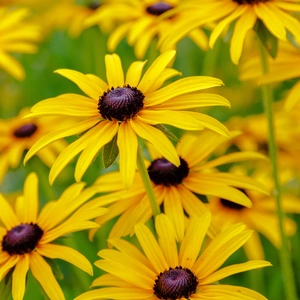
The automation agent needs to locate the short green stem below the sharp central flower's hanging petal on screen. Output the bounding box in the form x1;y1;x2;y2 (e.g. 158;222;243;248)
137;148;160;217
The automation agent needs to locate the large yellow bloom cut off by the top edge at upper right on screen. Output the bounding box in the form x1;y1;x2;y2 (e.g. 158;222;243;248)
159;0;300;64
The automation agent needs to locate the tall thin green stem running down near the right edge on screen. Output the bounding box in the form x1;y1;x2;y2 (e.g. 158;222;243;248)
260;39;297;300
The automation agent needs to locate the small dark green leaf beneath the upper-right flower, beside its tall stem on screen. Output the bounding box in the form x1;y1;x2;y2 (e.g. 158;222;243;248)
254;19;278;58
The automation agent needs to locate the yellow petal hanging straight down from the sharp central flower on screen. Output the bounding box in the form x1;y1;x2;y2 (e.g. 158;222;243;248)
117;122;138;188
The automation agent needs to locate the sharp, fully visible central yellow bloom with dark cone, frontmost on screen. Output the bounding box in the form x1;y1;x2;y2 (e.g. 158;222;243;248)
25;50;229;187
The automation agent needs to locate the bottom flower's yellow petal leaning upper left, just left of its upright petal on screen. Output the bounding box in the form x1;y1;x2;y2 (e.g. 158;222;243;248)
134;223;169;274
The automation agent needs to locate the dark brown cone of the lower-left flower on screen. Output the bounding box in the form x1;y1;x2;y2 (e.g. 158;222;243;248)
2;223;43;255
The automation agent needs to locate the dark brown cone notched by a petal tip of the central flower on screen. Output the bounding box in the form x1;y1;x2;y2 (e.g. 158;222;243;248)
148;157;189;186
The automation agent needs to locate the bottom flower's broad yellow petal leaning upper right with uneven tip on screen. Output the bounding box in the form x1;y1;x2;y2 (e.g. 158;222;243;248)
179;213;211;269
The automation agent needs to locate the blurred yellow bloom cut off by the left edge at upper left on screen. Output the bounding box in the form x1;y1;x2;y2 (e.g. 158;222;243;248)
0;7;40;80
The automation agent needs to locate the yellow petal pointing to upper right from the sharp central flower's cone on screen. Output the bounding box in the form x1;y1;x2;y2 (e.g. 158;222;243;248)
137;50;176;95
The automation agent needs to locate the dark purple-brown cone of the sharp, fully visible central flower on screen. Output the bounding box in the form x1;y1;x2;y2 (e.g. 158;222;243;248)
98;84;145;122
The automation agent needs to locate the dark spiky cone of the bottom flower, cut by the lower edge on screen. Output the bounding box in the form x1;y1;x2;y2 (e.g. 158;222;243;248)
153;266;198;300
